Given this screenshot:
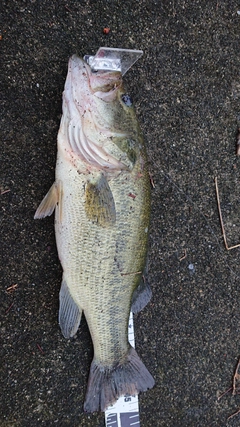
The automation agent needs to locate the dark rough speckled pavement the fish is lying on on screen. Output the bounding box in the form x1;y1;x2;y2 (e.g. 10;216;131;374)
0;0;240;427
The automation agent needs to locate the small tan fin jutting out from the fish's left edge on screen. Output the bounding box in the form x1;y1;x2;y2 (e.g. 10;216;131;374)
34;181;62;219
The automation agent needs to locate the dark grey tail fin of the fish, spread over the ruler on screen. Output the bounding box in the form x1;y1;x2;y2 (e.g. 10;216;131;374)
84;347;154;412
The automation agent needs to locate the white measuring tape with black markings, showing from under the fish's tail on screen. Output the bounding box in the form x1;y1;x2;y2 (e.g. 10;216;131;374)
105;312;140;427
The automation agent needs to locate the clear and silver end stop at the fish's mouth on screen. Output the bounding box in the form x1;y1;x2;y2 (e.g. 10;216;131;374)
83;47;143;75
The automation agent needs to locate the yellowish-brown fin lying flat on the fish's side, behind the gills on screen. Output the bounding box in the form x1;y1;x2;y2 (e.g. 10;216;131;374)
85;175;116;227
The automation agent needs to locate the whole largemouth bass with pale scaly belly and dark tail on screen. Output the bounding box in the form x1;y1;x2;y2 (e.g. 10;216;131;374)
34;55;154;412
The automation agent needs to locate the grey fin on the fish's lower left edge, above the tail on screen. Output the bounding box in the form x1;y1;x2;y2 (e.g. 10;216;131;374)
58;278;82;338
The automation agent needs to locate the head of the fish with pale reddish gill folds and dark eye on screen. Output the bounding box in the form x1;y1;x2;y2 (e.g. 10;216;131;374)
59;55;141;173
